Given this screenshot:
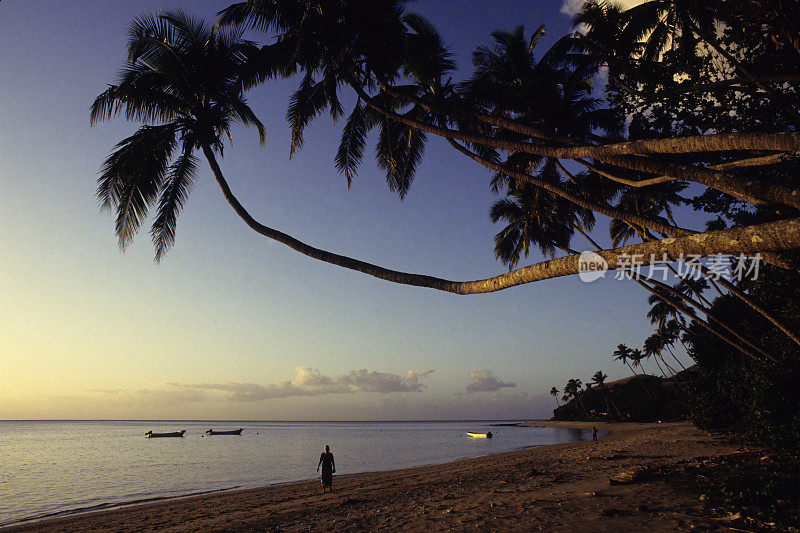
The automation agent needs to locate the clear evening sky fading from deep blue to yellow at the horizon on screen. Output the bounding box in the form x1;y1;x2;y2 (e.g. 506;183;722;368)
0;0;680;420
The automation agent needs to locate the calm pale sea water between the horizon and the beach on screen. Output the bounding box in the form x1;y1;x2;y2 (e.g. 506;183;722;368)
0;421;591;525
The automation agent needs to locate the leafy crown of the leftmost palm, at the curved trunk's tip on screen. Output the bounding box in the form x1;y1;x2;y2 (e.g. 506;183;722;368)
91;11;266;261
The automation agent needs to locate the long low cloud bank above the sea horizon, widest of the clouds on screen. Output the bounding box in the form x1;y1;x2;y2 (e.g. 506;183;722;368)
94;366;433;402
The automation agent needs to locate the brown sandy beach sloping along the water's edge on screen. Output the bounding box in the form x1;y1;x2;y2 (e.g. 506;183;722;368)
3;422;752;532
